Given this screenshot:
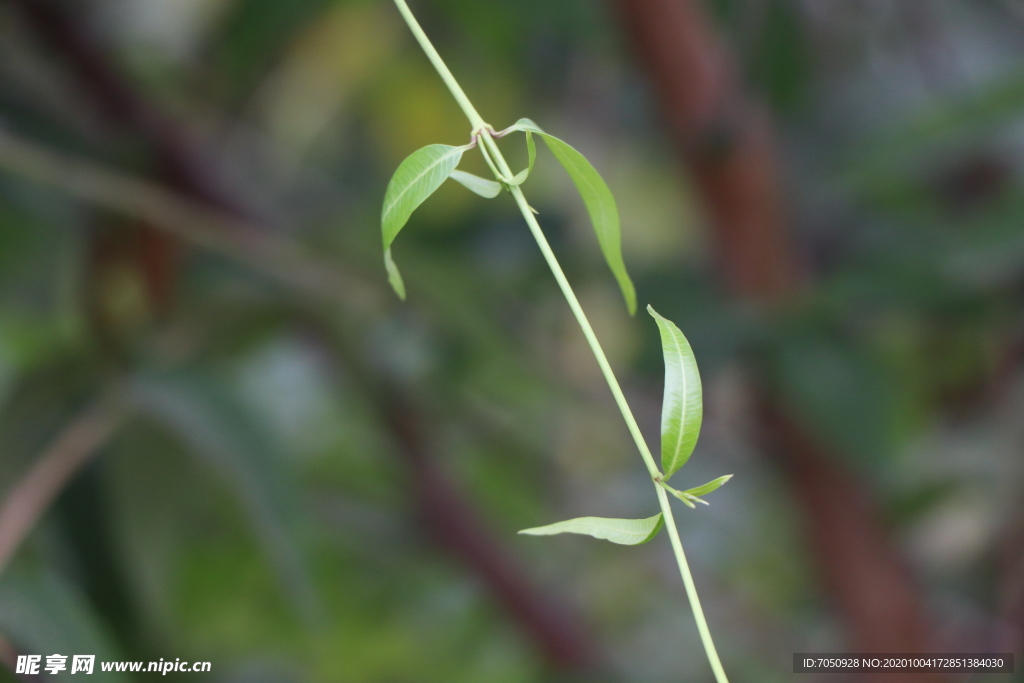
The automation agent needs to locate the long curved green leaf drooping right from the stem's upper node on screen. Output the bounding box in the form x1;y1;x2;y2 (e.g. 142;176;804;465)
509;119;637;315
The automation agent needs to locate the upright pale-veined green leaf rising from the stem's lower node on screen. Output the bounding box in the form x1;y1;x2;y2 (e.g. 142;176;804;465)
647;306;703;479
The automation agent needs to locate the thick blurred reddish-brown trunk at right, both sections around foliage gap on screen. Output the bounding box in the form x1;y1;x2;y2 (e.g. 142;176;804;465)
614;0;942;680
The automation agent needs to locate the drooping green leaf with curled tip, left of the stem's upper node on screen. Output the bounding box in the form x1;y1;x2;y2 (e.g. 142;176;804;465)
381;144;469;299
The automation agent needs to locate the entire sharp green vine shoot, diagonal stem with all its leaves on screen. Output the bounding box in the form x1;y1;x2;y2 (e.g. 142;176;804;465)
381;0;732;683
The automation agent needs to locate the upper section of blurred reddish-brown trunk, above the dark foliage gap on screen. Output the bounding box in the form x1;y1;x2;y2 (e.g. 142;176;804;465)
615;0;800;301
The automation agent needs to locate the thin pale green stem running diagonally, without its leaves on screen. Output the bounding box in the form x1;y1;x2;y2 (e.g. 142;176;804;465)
394;0;729;683
